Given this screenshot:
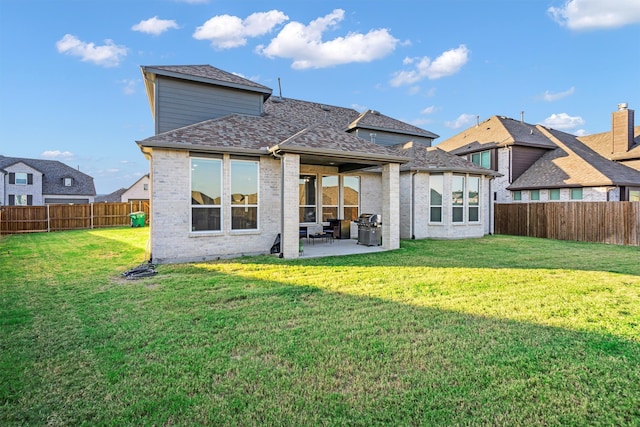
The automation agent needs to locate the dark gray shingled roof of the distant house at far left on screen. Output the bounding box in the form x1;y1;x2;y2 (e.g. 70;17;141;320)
0;155;96;196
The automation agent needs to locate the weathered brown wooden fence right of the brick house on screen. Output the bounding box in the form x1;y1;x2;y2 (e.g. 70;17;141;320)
494;202;640;246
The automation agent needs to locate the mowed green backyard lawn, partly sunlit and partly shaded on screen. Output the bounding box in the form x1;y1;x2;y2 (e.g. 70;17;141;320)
0;228;640;426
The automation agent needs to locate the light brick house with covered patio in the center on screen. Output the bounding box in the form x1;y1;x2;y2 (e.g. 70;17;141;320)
137;65;499;262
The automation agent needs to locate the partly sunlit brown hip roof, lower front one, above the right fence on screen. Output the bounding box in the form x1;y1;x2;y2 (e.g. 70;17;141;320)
508;126;640;190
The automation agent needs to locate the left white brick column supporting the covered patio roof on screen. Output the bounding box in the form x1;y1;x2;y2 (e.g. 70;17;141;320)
280;153;300;258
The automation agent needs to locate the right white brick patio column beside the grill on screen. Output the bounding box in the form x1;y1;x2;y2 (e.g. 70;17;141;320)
382;163;400;249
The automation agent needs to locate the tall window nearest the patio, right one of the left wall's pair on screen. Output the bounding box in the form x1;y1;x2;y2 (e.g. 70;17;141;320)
231;160;259;230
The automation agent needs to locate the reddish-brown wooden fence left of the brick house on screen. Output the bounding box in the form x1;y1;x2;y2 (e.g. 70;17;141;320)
0;201;149;234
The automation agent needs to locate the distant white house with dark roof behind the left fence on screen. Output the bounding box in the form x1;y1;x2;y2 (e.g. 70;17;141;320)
0;155;96;206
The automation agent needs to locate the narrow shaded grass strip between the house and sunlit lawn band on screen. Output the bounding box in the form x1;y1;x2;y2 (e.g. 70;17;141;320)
249;235;640;276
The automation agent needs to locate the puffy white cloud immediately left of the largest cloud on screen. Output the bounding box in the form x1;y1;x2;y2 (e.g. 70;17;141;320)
193;10;289;49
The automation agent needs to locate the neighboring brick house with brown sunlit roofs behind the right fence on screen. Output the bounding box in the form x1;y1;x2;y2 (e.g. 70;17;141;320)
438;110;640;203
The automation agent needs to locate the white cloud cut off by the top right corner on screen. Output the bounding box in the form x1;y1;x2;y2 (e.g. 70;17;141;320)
547;0;640;30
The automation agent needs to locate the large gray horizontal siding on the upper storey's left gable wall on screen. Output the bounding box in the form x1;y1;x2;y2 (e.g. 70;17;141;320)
156;76;263;134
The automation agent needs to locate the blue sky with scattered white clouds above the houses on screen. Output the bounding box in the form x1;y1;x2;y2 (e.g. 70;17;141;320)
0;0;640;194
